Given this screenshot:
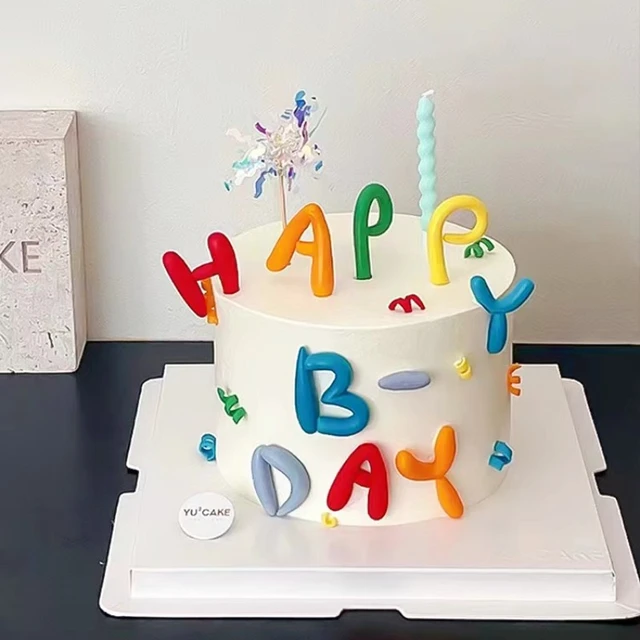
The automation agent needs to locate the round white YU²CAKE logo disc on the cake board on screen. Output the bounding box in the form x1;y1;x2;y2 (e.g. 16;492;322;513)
178;493;235;540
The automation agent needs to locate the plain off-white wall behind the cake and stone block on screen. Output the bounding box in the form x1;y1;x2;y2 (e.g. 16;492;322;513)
0;0;640;342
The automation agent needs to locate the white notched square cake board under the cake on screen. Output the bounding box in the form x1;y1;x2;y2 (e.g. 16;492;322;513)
100;365;640;620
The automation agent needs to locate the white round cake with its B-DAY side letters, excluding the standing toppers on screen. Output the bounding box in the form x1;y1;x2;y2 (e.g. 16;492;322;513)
213;213;515;526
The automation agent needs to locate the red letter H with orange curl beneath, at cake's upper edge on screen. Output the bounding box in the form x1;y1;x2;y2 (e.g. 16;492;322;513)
162;231;240;324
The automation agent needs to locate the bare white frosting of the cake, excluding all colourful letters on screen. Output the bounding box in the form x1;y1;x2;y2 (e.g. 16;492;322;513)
212;213;515;525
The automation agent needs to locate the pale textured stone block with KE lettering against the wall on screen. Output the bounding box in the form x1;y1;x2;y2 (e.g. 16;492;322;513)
0;111;87;372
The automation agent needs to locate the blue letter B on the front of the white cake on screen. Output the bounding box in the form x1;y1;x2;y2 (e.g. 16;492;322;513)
295;347;369;437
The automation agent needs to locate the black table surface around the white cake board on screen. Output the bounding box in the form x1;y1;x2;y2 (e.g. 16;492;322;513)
0;343;640;640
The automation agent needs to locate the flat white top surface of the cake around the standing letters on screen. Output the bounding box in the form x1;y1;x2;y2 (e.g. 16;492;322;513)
214;213;516;329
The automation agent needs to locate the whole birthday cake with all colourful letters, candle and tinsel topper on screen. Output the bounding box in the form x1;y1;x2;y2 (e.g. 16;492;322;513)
163;94;533;527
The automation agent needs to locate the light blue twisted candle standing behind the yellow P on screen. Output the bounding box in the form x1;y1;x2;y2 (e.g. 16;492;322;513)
416;90;436;231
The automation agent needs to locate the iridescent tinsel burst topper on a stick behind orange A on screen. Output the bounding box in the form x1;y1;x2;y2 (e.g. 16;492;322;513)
224;91;326;227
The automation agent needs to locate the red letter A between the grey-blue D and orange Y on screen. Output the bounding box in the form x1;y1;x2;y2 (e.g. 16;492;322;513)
327;442;389;520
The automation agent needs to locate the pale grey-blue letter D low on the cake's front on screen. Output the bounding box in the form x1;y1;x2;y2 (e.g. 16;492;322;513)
251;444;311;517
